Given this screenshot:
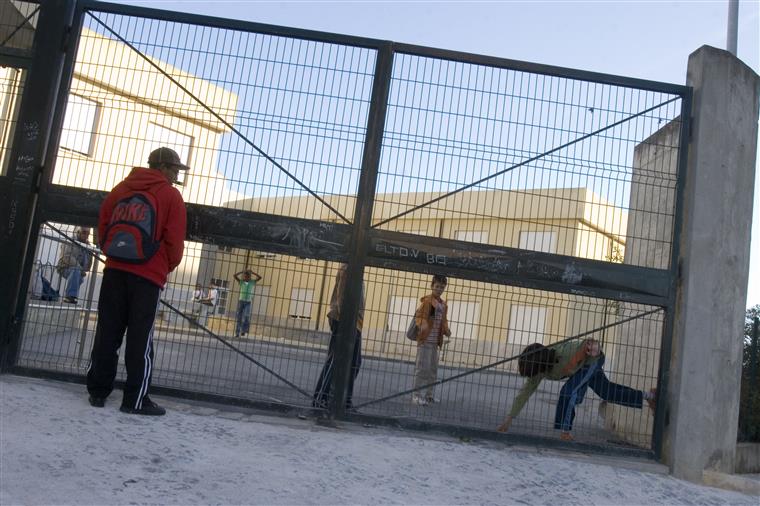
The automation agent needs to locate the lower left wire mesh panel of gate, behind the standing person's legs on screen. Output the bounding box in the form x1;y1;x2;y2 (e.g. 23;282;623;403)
19;223;342;407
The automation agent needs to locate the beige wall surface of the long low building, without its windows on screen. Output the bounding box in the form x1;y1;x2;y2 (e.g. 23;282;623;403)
205;189;625;370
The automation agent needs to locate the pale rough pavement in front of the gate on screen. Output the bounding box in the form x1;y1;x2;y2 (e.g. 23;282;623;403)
0;374;757;505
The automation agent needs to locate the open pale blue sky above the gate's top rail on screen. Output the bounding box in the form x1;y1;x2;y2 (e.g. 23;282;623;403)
108;0;760;307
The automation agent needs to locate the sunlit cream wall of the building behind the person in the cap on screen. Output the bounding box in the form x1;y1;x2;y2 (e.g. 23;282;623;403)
52;29;239;284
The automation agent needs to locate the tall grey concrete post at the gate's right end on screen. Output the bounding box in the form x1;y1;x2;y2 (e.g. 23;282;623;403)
663;46;760;481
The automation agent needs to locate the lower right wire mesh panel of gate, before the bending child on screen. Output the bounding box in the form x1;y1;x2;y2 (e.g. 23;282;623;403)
355;269;662;447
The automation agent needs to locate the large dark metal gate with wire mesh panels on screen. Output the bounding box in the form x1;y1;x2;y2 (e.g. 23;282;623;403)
0;0;691;455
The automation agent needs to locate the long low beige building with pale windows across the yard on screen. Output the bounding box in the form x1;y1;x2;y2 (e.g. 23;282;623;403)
199;188;627;369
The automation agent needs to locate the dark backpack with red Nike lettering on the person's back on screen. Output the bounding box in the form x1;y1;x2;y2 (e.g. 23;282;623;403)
100;192;161;264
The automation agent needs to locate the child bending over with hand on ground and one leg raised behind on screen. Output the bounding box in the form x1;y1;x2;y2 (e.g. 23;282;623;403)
496;339;656;441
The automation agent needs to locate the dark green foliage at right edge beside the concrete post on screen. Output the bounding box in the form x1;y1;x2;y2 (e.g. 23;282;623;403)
739;305;760;442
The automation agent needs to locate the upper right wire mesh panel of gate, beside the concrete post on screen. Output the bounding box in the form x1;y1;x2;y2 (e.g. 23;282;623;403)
373;54;681;268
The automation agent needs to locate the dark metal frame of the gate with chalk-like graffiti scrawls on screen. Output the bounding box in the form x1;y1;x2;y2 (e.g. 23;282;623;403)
0;0;692;459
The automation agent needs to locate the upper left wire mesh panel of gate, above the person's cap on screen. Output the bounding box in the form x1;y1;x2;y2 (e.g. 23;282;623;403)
53;11;375;222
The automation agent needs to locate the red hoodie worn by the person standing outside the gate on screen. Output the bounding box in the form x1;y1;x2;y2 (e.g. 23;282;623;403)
98;167;187;288
